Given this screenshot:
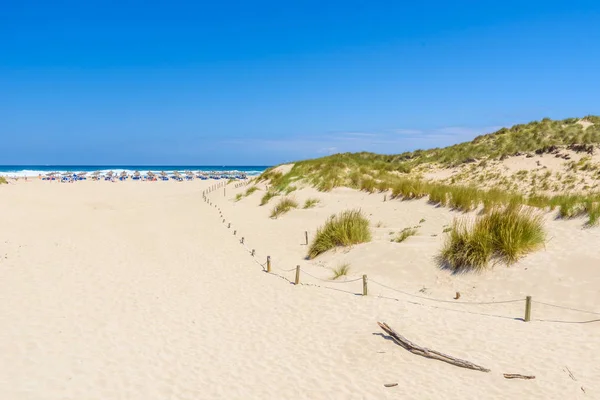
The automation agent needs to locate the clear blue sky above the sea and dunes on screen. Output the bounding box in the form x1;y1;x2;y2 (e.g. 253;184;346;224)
0;0;600;165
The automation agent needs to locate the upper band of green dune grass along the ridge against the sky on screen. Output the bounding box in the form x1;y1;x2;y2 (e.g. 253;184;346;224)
260;115;600;191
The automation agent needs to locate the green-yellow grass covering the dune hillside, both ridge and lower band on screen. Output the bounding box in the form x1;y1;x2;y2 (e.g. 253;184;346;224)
259;116;600;227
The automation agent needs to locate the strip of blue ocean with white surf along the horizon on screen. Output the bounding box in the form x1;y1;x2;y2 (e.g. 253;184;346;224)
0;165;269;177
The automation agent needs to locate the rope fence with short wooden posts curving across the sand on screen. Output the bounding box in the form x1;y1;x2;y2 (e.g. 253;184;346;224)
202;180;600;324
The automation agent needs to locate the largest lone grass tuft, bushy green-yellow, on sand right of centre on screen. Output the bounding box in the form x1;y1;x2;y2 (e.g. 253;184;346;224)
438;206;546;272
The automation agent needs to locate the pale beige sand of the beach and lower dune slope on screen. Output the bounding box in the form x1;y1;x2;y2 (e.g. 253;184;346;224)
0;181;600;400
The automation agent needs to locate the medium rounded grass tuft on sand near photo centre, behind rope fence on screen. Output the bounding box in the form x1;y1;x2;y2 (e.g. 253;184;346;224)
308;210;371;259
